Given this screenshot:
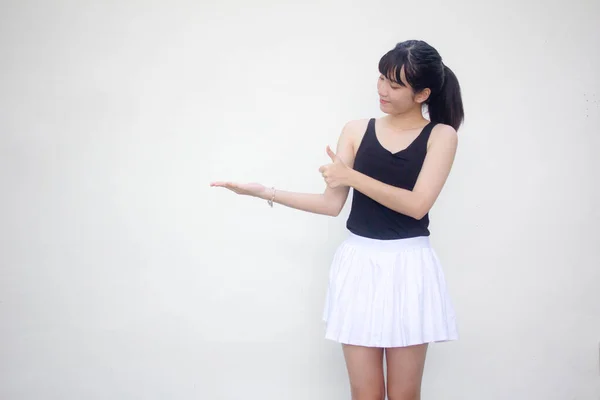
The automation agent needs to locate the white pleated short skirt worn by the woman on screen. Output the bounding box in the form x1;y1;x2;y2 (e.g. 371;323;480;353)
323;233;458;348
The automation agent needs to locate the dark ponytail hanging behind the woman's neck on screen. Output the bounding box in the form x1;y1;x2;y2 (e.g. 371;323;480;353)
427;65;465;131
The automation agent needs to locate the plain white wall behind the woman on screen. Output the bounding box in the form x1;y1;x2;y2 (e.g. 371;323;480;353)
0;0;600;400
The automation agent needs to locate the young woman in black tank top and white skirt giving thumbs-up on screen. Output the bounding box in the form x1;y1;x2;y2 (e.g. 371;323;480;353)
211;40;464;400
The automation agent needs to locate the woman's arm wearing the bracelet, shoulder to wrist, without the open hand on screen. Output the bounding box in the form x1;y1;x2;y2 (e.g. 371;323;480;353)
259;123;355;217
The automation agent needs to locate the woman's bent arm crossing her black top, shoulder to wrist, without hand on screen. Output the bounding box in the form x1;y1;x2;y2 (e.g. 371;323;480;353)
344;124;458;219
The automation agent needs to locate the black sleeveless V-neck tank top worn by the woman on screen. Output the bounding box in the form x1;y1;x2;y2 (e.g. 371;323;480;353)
346;118;435;240
